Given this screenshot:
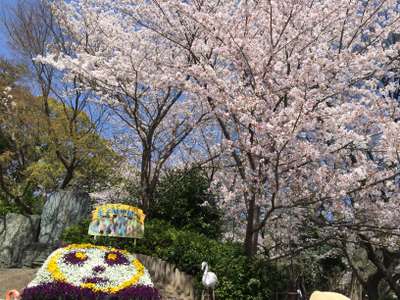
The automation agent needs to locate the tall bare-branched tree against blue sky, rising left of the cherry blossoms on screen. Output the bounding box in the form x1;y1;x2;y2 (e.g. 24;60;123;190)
3;0;109;189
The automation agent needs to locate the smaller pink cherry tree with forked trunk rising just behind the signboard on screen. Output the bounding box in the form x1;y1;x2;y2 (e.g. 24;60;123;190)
38;1;211;209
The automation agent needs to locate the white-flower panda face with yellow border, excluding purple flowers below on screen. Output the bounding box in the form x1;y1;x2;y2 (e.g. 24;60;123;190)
28;244;153;294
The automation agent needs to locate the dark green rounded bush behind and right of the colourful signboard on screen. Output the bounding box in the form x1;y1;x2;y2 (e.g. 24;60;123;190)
149;169;222;238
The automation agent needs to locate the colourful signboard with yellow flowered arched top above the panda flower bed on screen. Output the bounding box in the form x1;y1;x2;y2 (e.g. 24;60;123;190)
88;204;146;238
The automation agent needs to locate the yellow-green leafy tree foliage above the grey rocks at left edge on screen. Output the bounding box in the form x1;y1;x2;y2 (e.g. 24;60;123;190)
0;58;120;213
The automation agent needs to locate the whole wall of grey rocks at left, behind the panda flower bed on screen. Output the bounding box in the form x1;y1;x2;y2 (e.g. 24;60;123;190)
0;191;91;268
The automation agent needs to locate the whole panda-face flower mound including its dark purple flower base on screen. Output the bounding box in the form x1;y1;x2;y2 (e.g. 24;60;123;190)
22;244;160;300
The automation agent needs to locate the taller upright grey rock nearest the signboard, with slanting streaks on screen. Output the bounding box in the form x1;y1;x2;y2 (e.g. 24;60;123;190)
39;191;90;244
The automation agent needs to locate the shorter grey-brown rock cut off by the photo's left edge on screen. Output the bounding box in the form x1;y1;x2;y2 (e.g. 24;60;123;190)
0;213;40;268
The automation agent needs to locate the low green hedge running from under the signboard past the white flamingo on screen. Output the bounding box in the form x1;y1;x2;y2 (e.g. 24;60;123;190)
63;219;287;300
